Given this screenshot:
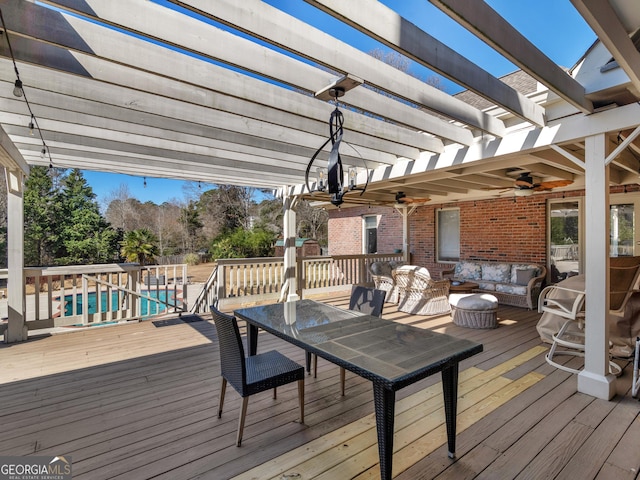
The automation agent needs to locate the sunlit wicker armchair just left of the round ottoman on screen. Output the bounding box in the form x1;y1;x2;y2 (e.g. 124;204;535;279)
392;265;451;315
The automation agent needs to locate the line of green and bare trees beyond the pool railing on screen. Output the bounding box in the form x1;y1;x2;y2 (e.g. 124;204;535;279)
0;166;328;268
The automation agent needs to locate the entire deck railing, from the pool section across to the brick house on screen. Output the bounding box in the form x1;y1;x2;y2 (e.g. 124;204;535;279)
0;254;402;329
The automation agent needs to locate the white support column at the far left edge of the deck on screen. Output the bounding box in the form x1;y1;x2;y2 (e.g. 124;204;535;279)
4;168;28;343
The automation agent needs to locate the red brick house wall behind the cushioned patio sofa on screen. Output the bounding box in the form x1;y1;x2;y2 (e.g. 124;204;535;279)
329;191;584;277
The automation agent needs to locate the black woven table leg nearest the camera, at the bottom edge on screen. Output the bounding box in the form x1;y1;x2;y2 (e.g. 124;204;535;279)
373;382;396;480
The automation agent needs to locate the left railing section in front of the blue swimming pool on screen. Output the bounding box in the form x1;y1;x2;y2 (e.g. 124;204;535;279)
18;264;187;329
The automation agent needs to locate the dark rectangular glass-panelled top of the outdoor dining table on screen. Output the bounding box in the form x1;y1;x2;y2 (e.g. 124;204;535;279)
235;300;482;390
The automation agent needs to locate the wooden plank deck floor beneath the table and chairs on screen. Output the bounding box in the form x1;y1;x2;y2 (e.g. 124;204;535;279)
0;296;640;480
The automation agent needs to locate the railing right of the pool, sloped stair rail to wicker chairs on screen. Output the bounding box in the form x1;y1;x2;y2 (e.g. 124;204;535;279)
191;253;402;313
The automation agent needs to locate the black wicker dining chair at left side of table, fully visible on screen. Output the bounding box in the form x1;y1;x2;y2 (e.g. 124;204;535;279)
211;306;304;447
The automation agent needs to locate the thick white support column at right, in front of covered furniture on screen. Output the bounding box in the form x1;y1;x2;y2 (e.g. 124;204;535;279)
578;134;615;400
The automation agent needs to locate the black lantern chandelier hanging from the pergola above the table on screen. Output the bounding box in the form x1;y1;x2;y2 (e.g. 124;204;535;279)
304;86;369;206
